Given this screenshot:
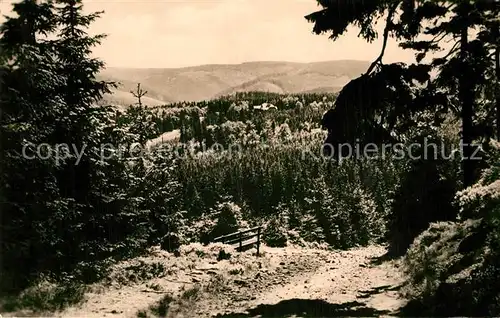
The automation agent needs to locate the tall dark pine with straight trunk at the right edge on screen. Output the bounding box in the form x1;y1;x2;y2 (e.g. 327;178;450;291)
400;0;500;186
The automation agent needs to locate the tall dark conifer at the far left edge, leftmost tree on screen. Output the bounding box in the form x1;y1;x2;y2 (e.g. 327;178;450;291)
0;0;64;290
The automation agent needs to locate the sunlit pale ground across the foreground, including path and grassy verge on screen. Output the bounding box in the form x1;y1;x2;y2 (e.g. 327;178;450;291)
3;244;404;318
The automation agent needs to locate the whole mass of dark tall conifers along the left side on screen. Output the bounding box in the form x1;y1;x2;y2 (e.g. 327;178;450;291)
0;0;147;290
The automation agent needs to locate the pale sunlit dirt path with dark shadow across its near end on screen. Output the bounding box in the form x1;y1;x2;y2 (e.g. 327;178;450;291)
208;246;404;317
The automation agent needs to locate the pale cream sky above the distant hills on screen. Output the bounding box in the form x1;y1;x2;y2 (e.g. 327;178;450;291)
0;0;413;67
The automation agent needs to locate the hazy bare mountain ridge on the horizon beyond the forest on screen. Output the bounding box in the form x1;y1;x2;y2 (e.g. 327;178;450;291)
99;60;370;106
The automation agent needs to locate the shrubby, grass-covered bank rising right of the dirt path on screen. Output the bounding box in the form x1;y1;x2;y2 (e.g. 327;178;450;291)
404;140;500;316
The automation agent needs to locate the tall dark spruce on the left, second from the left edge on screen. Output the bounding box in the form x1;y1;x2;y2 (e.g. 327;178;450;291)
49;0;152;269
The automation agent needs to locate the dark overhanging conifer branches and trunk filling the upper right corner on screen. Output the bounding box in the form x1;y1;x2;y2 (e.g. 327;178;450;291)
306;0;500;186
